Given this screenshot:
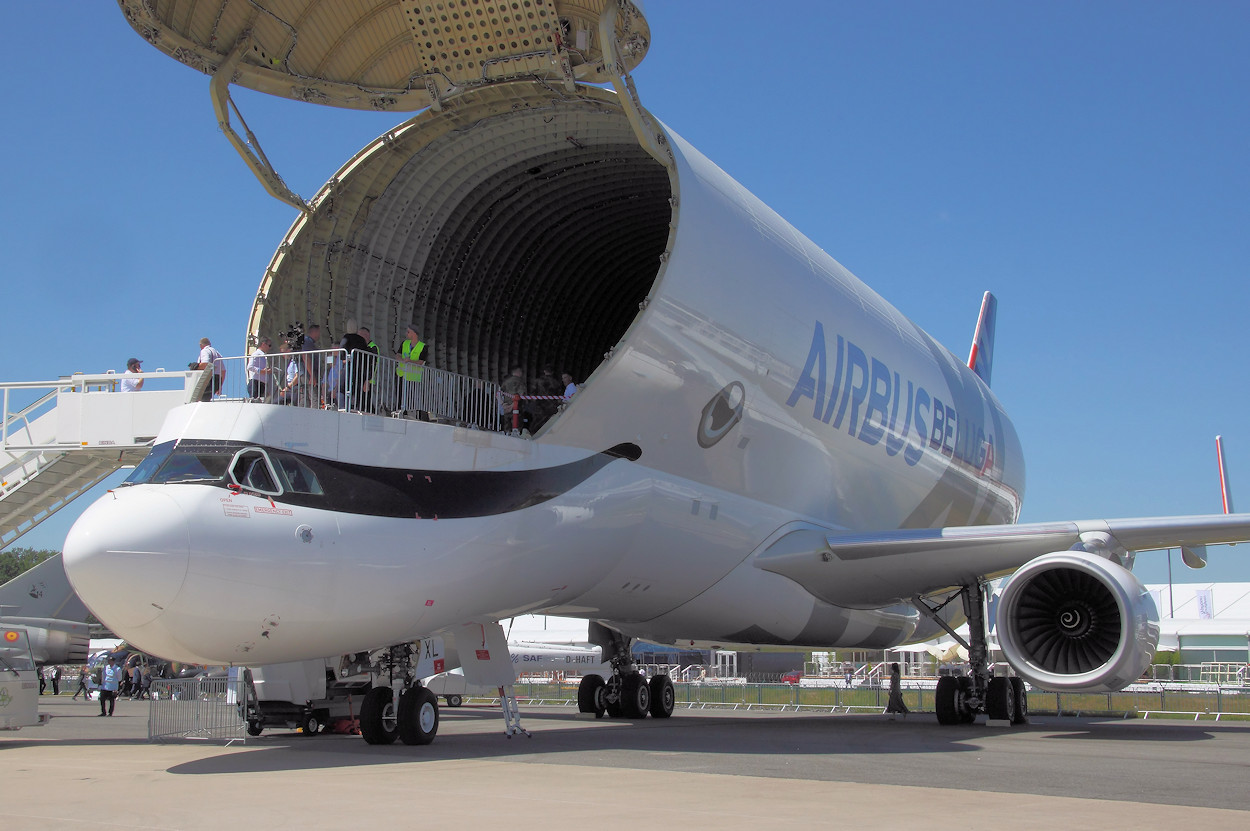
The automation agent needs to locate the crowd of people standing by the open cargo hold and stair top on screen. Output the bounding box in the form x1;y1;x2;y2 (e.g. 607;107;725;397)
120;320;579;434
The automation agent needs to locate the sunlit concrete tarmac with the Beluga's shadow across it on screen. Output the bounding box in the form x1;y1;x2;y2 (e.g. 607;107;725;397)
0;695;1250;831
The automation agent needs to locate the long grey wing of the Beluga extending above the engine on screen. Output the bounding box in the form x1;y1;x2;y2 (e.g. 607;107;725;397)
755;514;1250;609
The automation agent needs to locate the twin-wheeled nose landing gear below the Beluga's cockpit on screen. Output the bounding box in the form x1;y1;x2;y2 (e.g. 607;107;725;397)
360;644;439;745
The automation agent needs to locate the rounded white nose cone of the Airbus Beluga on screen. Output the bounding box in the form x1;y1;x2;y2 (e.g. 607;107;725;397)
63;486;191;635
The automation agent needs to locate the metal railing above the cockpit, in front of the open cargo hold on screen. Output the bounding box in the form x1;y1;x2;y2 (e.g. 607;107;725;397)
201;349;513;430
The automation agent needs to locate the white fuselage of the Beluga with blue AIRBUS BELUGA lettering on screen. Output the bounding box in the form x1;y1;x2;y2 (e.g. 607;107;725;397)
65;85;1024;664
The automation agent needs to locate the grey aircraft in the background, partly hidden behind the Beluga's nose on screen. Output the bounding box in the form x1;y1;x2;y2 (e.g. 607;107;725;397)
0;554;91;666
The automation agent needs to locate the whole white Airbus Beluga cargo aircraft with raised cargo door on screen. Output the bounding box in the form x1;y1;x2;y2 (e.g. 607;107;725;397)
65;0;1250;744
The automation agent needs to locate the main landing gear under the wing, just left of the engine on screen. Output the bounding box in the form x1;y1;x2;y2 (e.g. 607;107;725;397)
911;581;1029;725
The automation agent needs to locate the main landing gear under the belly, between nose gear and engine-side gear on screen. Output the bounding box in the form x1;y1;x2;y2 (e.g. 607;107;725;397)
578;622;676;719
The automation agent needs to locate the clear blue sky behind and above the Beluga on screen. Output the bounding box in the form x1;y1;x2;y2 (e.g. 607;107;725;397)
0;0;1250;582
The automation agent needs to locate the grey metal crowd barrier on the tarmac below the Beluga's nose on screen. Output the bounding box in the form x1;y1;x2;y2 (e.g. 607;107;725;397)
148;674;248;742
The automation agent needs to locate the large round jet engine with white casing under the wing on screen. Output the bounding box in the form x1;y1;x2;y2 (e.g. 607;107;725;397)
996;551;1159;692
